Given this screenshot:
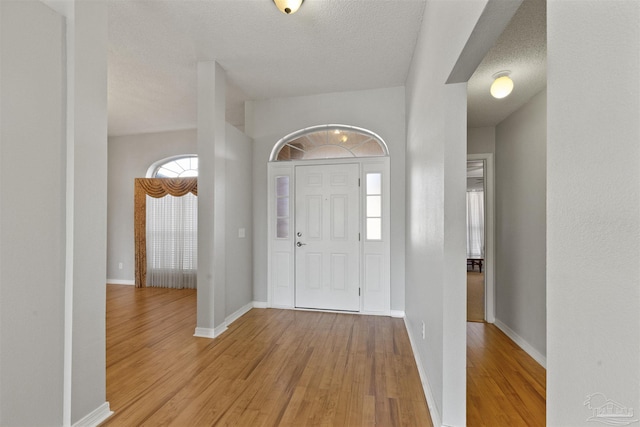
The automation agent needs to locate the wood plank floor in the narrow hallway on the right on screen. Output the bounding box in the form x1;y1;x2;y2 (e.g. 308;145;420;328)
467;322;546;427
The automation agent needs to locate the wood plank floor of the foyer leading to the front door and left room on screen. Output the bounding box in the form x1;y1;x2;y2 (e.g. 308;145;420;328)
103;285;432;426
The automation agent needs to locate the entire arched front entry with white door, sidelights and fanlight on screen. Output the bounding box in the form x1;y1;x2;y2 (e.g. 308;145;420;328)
268;125;390;315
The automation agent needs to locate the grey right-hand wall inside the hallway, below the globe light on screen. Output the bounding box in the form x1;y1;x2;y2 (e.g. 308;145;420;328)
495;90;547;361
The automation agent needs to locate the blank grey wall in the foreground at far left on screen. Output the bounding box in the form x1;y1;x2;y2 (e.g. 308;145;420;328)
0;1;65;426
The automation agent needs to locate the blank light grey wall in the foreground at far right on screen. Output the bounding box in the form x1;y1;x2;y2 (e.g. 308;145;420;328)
547;0;640;426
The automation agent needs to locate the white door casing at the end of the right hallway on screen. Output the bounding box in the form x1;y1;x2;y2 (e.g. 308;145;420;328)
467;153;496;323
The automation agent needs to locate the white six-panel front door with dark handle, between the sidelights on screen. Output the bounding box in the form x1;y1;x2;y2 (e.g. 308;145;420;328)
295;164;360;311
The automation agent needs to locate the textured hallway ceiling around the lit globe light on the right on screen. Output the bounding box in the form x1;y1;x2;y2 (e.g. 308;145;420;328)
467;0;547;127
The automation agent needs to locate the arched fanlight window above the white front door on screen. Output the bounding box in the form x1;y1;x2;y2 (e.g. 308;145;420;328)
269;125;389;161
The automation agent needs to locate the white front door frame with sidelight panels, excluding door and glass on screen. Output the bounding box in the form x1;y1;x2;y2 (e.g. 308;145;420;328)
267;156;391;316
